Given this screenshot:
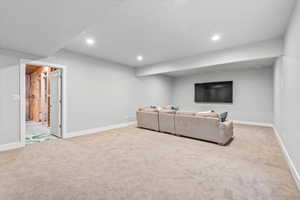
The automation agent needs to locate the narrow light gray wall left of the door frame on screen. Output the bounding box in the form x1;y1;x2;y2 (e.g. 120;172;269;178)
0;48;38;146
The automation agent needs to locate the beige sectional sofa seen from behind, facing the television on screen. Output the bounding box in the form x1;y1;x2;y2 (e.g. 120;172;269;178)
136;108;233;145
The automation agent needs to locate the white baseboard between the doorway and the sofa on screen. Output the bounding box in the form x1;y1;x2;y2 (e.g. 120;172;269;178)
64;121;136;138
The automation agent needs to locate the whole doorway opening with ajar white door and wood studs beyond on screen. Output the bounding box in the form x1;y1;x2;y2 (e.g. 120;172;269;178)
25;65;62;144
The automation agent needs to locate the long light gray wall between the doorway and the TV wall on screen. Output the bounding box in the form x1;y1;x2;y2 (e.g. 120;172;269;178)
43;51;171;132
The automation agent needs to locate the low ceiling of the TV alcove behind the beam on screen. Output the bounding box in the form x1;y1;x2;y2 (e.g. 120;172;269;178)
165;58;276;77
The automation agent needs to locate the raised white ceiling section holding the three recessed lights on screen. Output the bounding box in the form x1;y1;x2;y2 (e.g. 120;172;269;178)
63;0;294;66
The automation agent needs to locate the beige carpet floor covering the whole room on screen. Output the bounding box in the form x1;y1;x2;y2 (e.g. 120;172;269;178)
0;125;300;200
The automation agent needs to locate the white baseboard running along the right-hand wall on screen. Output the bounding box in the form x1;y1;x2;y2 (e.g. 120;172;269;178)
273;126;300;190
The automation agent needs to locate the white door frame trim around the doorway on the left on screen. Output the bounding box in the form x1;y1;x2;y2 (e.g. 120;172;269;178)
20;60;67;145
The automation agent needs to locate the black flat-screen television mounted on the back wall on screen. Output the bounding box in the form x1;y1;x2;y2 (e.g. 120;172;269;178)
195;81;233;103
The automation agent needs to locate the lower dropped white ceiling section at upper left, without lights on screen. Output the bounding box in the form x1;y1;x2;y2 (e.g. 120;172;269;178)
0;0;122;56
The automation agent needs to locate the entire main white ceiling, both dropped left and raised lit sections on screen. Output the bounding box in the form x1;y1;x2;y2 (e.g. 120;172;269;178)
0;0;294;66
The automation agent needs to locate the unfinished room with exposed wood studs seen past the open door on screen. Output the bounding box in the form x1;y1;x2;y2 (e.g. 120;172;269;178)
26;65;56;140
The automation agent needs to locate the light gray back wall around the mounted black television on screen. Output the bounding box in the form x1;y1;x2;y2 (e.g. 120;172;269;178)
172;67;273;123
